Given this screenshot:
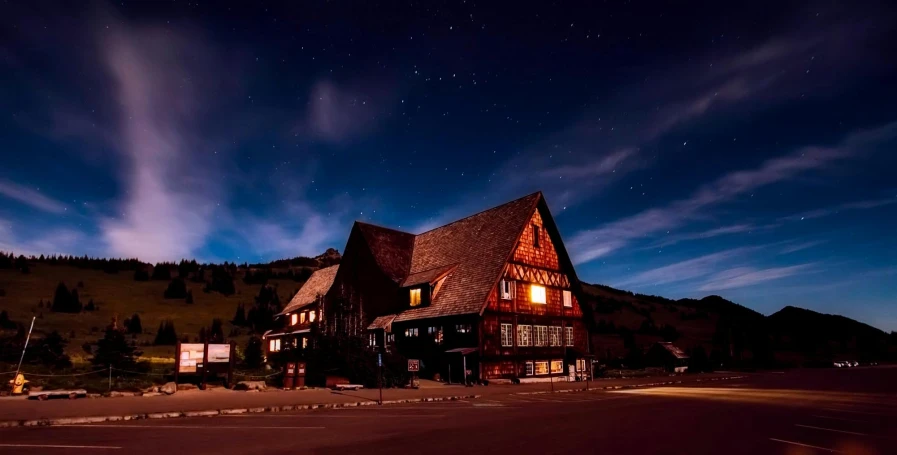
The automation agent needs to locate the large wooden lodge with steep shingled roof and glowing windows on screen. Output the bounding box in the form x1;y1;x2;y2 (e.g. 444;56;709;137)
268;193;589;381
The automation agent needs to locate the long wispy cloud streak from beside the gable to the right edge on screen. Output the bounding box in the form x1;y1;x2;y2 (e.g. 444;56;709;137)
570;122;897;263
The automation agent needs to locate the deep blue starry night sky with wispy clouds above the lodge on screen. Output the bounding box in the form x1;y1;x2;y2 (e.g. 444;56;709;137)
0;1;897;330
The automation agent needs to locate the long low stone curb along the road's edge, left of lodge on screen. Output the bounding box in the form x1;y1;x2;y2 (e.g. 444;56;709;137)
0;395;481;428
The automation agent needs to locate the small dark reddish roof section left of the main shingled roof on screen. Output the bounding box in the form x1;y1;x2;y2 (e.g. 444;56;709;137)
355;221;414;283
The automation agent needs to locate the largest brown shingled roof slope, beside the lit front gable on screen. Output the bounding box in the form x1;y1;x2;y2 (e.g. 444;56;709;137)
395;193;542;322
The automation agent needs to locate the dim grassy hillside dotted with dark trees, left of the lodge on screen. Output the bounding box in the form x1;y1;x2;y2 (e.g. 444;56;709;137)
0;264;302;360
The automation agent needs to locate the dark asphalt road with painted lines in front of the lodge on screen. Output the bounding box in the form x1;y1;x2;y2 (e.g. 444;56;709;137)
0;367;897;455
